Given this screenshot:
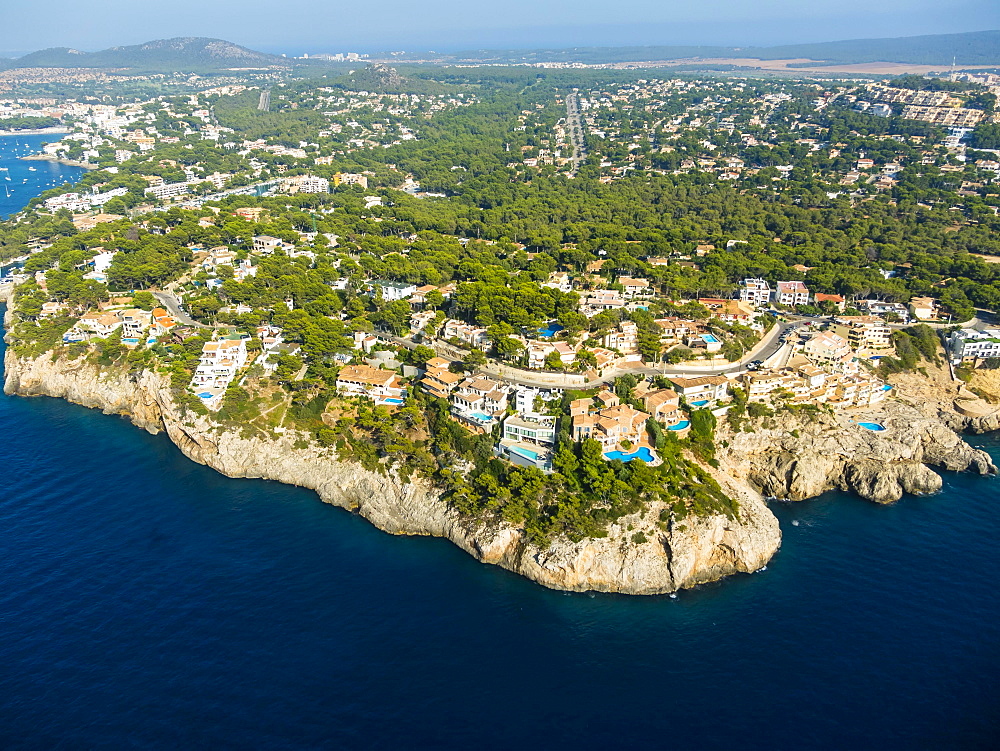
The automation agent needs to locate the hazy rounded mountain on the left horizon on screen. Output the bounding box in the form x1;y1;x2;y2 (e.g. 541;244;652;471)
12;37;282;71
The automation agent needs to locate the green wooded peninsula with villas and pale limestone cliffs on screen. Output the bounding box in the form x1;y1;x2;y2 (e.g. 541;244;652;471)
0;60;1000;595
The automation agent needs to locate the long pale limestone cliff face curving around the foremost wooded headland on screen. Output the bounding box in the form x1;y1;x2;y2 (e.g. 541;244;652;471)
4;349;781;594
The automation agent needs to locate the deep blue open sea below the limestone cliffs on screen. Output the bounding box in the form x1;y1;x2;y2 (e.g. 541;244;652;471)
0;330;1000;751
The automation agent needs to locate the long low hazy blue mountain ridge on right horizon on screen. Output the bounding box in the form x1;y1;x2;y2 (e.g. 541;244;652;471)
452;31;1000;68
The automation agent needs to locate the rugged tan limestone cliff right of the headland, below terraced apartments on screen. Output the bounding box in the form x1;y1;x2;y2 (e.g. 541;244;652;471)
719;401;997;503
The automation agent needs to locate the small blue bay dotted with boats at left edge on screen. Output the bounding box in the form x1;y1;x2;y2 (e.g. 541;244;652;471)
0;133;87;219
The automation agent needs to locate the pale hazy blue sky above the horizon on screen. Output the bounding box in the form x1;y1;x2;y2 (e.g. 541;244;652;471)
0;0;1000;55
